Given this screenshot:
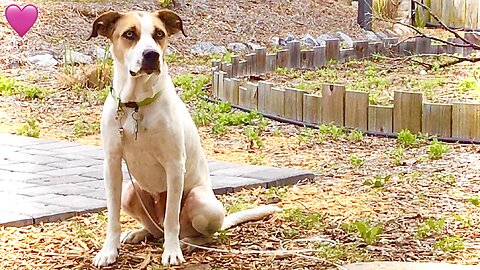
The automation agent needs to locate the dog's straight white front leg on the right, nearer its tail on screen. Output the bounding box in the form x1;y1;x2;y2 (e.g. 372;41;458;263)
162;159;185;265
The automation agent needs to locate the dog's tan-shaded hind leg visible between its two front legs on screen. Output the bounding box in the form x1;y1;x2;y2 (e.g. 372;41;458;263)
121;183;165;244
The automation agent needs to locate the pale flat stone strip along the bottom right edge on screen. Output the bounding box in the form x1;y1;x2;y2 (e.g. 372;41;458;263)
344;262;480;270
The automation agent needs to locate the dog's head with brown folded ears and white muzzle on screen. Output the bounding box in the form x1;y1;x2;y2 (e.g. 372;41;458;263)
87;10;185;77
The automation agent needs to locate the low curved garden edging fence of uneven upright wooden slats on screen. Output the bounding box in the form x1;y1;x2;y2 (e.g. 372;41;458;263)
212;34;480;140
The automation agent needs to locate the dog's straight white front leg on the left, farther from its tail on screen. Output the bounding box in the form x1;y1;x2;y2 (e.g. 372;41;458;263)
93;154;123;266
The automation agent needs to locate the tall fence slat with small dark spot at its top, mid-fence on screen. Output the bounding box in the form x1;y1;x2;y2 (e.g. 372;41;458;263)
322;84;345;126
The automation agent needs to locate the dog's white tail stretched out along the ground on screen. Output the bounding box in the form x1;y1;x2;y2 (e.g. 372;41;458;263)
222;205;282;230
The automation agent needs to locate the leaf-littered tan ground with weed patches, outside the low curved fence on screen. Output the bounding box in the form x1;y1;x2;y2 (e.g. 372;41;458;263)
0;0;480;269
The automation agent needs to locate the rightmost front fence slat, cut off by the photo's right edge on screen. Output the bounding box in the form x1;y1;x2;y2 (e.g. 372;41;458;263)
452;102;480;139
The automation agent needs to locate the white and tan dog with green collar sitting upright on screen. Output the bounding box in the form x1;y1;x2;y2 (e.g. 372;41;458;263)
87;10;279;266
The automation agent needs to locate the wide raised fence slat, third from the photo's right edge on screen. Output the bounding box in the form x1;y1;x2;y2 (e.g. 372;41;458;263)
393;91;423;133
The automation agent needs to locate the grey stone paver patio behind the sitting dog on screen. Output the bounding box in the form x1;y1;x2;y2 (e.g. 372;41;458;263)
0;133;313;226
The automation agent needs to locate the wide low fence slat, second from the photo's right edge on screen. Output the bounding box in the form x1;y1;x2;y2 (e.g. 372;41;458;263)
422;103;452;137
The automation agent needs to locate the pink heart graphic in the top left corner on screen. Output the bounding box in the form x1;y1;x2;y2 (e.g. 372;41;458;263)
5;4;38;37
